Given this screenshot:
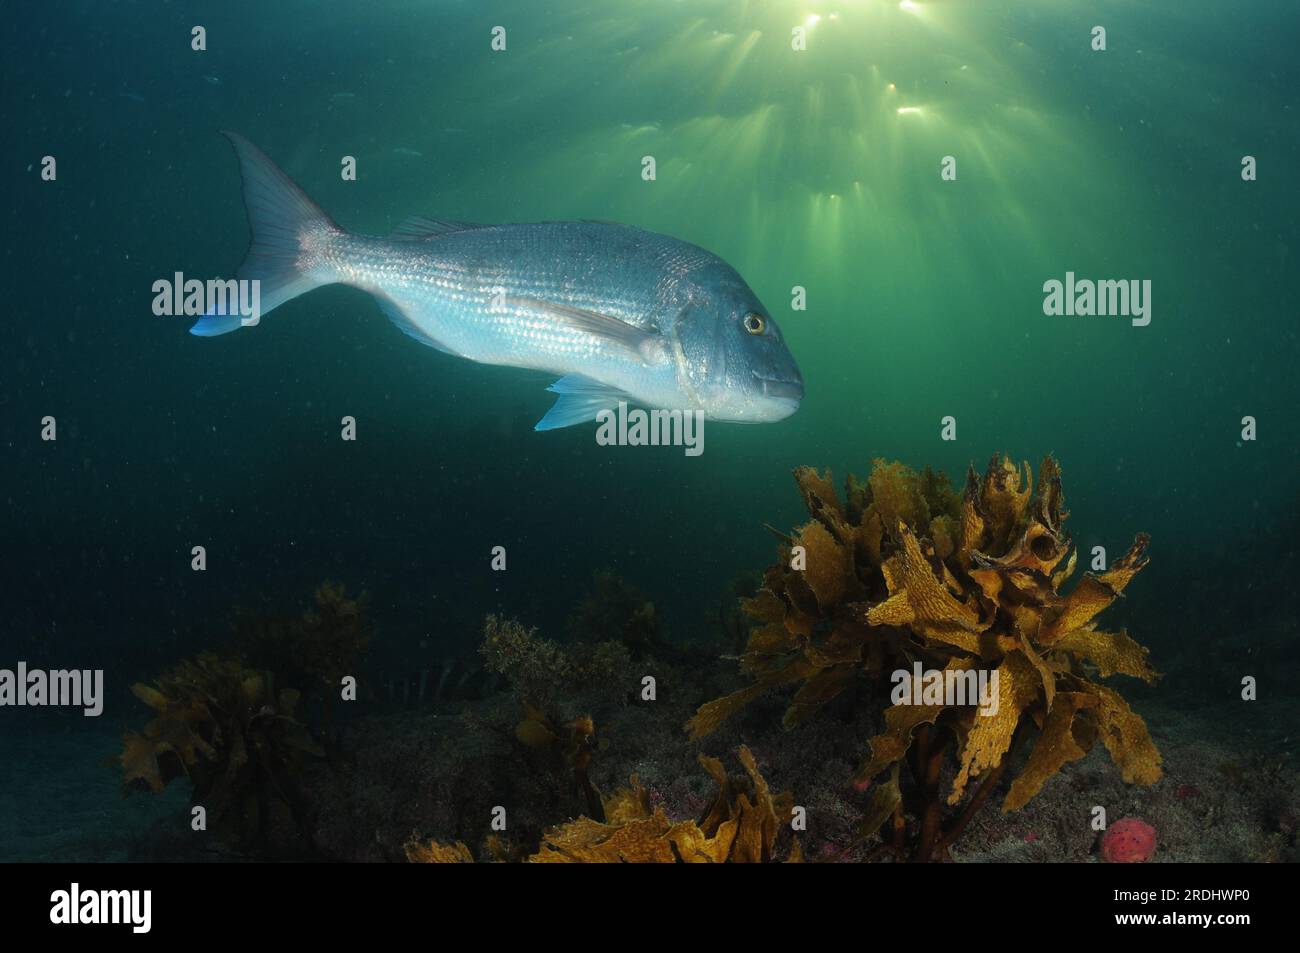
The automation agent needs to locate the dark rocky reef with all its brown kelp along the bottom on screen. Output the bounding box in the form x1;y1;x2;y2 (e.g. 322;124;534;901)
111;468;1300;863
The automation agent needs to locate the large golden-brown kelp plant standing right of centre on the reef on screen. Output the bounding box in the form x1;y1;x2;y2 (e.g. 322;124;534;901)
686;456;1161;861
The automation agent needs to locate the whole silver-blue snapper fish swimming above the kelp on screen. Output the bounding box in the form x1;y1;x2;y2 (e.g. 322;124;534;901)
190;133;803;430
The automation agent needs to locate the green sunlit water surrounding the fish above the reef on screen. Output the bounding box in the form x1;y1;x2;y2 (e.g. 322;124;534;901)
0;0;1300;738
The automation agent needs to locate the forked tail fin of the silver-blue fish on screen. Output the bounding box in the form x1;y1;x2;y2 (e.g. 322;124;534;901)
190;133;341;337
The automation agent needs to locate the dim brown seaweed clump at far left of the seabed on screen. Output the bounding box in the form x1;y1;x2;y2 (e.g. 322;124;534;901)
120;653;321;852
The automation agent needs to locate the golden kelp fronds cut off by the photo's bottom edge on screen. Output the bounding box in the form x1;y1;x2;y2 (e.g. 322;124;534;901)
406;746;802;863
